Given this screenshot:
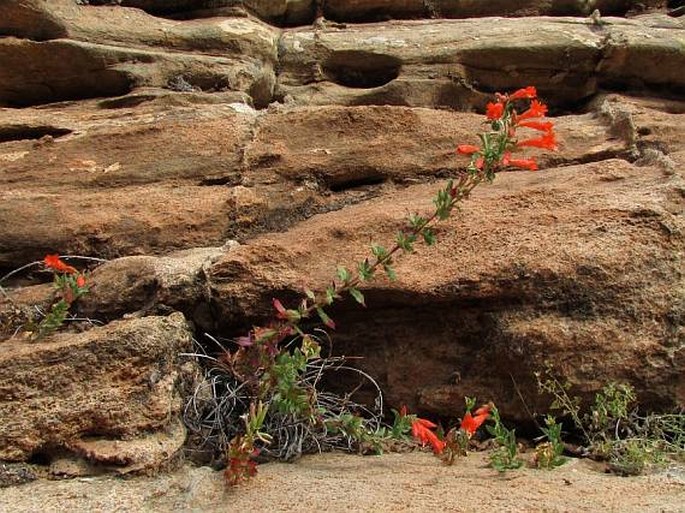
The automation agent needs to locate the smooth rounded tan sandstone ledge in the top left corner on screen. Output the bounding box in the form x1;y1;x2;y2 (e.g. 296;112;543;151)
0;0;278;106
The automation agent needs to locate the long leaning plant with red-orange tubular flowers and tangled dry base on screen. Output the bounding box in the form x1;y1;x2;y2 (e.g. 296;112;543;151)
186;87;557;483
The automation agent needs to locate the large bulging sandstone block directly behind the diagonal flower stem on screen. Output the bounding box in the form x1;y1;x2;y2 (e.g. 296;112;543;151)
208;98;685;416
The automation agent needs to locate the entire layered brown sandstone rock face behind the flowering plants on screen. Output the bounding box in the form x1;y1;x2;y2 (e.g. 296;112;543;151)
0;0;685;471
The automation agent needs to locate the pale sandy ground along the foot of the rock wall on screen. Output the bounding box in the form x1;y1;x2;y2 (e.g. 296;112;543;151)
0;452;685;513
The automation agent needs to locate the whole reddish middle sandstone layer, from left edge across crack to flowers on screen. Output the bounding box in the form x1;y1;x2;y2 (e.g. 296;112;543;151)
0;95;629;272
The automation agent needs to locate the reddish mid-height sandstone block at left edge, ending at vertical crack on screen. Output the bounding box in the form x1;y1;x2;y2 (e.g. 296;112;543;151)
0;99;254;269
